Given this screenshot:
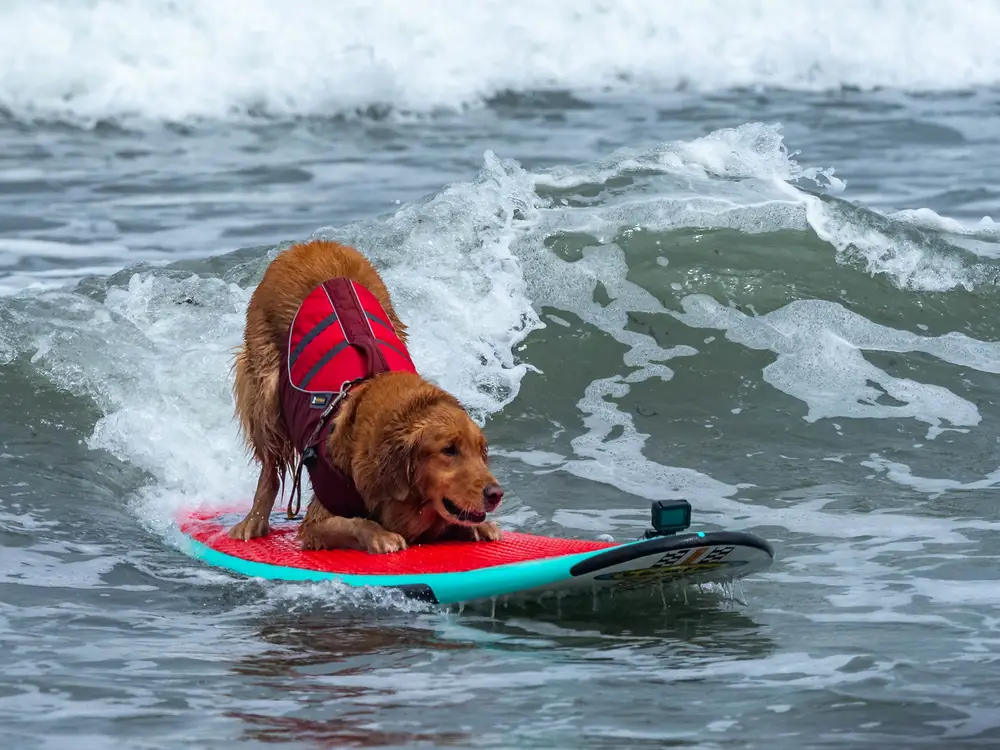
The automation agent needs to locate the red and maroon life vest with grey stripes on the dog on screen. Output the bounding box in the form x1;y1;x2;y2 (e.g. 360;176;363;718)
279;278;417;518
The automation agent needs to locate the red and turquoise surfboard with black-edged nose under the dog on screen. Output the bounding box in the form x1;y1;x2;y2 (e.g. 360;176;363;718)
177;501;774;604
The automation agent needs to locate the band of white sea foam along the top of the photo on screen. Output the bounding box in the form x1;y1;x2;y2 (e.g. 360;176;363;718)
0;0;1000;122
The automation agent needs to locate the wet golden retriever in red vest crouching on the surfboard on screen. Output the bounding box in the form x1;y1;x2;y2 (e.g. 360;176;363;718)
229;240;503;553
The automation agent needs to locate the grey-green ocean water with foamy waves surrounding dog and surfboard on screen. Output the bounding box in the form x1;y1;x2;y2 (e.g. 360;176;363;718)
0;0;1000;750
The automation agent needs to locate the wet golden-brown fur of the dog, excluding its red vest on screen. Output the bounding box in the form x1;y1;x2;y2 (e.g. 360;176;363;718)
229;240;503;553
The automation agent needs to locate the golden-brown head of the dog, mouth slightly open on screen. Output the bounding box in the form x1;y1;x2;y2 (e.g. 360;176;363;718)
378;398;503;526
